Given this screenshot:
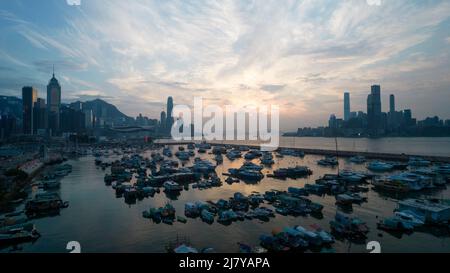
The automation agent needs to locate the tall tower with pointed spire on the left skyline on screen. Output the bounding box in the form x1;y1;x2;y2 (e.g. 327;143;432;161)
47;71;61;135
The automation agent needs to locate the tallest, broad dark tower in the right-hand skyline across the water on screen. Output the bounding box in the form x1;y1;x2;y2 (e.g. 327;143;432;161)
367;85;382;134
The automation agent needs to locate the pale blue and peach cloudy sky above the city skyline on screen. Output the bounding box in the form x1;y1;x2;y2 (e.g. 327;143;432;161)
0;0;450;130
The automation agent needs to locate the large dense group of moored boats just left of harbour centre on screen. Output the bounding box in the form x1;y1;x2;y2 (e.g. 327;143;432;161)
104;151;222;203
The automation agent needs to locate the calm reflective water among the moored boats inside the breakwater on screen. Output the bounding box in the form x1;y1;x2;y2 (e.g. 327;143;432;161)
0;146;450;253
